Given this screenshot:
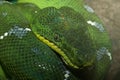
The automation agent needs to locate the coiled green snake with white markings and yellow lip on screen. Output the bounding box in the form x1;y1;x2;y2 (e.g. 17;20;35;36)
0;0;112;80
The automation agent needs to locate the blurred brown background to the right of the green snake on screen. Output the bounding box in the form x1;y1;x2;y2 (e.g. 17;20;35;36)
84;0;120;80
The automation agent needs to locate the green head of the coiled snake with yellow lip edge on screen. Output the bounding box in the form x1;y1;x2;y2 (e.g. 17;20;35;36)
31;6;109;69
